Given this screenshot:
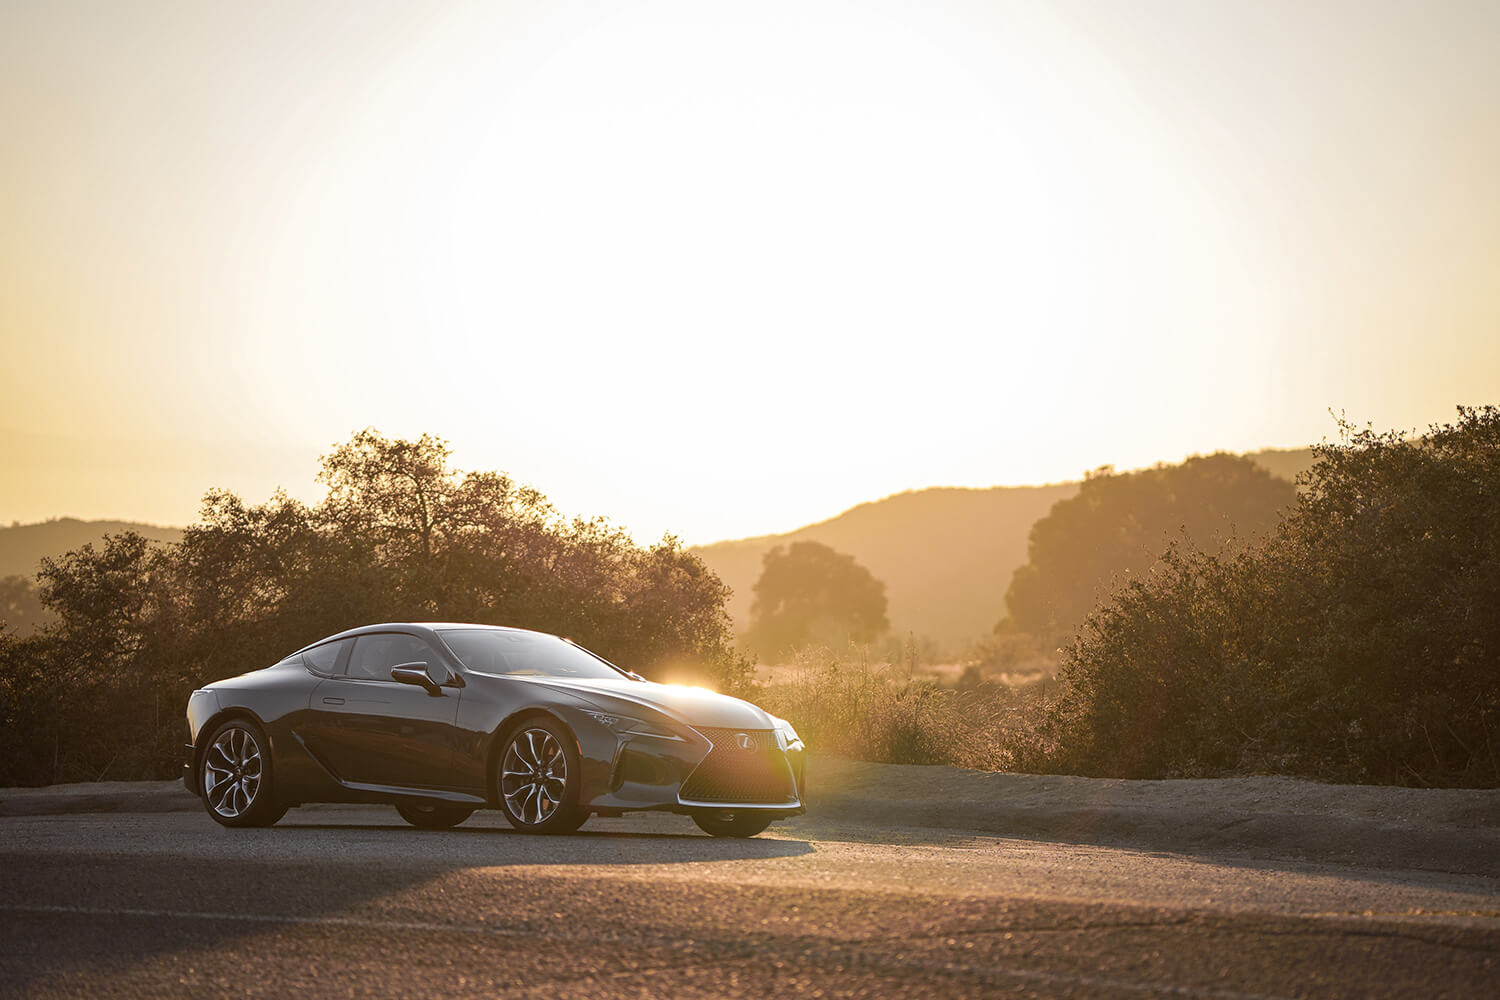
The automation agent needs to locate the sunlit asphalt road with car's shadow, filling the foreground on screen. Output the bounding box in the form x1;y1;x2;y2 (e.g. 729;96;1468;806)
0;807;1500;1000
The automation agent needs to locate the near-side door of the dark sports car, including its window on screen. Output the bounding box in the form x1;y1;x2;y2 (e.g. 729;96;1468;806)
309;631;464;789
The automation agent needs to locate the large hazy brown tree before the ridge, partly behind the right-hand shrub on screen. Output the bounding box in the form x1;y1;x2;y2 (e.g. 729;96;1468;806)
1002;454;1296;639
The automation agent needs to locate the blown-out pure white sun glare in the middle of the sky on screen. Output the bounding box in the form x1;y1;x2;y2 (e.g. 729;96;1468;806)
228;3;1260;537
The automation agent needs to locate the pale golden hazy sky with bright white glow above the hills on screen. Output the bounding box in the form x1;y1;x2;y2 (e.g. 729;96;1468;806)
0;0;1500;541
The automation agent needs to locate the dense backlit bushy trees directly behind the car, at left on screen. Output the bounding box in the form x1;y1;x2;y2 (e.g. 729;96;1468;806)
0;430;749;784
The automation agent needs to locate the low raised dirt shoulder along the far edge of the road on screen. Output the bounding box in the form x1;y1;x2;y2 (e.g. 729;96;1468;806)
0;757;1500;876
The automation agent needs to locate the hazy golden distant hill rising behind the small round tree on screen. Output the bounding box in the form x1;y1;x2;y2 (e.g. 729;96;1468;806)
689;448;1313;654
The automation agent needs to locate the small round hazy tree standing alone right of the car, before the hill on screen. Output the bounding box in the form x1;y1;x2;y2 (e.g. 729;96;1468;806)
746;541;890;657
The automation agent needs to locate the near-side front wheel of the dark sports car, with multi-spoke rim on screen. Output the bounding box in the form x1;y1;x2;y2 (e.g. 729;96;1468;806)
495;715;588;834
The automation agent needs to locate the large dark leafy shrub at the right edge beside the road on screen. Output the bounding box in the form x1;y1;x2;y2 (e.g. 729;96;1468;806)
1037;408;1500;786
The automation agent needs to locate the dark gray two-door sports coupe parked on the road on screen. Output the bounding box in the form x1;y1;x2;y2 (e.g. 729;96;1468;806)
183;624;803;837
